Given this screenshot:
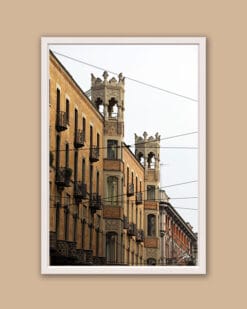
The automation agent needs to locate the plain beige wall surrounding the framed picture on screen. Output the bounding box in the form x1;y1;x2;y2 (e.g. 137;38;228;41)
0;0;247;309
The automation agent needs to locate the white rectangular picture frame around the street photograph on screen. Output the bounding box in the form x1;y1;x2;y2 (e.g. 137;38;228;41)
41;36;206;275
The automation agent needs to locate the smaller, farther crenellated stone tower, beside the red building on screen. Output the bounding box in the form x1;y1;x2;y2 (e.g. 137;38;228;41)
135;132;161;265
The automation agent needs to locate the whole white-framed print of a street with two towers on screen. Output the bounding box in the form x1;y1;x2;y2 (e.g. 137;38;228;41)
41;37;206;275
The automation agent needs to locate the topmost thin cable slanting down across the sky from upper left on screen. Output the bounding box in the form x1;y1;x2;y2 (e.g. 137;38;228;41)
53;51;198;102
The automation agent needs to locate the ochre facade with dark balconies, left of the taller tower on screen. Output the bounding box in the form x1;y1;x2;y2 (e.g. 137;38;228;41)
49;53;105;265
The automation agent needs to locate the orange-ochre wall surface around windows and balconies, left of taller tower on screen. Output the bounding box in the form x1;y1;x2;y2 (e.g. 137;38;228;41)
49;55;104;256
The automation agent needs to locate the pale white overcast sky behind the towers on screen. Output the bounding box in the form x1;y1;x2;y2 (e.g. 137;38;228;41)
50;44;198;232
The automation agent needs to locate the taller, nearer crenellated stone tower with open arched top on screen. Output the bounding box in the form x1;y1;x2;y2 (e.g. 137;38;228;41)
91;71;124;264
